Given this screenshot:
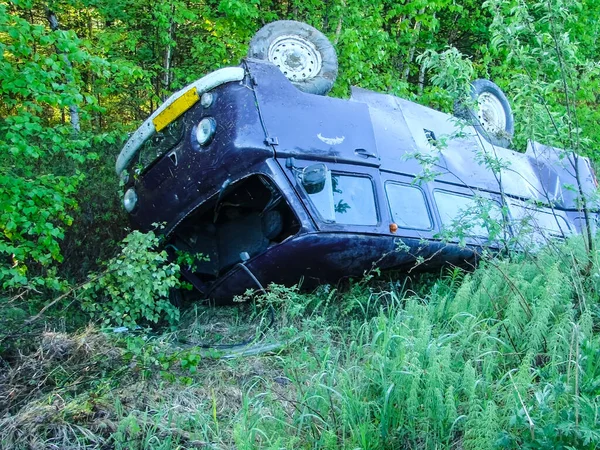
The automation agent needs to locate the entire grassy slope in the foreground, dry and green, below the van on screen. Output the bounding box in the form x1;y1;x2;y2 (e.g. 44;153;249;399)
0;237;600;449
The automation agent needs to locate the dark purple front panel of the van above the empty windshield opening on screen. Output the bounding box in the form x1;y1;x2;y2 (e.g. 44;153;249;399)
131;75;274;233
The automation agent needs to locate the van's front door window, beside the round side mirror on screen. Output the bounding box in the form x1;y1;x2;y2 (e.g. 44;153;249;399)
309;172;377;225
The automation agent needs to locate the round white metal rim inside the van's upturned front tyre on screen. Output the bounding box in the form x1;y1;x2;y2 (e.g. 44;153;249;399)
268;35;322;81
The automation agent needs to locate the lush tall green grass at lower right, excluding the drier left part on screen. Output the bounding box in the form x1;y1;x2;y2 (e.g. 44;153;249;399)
236;240;600;449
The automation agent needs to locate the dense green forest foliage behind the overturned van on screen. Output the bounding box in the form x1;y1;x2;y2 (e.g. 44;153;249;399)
0;0;600;290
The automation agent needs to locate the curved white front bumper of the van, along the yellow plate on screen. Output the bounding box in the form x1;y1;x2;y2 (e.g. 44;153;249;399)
115;67;244;175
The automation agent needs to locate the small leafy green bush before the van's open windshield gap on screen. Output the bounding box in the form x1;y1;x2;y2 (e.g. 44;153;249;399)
81;231;181;328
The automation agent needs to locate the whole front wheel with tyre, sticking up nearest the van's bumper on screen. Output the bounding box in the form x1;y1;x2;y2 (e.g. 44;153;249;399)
248;20;338;95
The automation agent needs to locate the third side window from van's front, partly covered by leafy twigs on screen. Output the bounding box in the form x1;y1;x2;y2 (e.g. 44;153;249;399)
434;191;502;237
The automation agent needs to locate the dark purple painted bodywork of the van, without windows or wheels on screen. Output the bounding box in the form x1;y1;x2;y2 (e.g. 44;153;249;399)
117;60;598;300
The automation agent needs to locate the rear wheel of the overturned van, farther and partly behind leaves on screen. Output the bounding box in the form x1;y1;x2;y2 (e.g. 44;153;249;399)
454;79;515;147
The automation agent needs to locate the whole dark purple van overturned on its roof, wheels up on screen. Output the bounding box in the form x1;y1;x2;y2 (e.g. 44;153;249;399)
116;21;596;299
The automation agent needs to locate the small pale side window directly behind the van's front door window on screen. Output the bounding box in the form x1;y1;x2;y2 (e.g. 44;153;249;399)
385;183;432;230
